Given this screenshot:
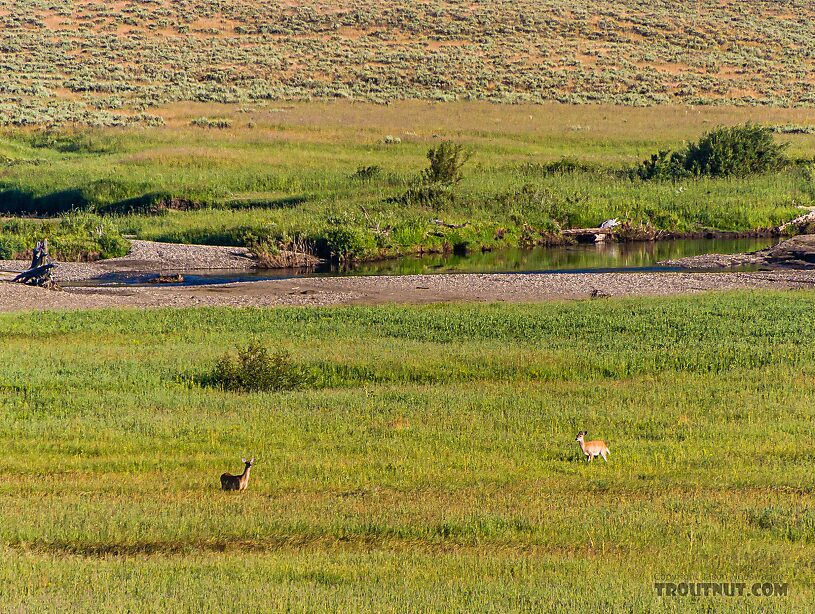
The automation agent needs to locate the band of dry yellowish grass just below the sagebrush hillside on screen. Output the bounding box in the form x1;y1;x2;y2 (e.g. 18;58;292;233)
155;100;815;150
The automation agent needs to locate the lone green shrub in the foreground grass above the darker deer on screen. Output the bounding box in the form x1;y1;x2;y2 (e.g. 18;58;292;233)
209;341;307;392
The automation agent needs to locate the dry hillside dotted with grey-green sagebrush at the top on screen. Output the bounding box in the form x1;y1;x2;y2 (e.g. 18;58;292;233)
0;0;815;125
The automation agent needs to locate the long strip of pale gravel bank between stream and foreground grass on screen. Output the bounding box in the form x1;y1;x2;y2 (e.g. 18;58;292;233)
0;270;815;311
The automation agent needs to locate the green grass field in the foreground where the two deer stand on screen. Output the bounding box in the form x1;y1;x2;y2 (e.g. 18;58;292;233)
0;292;815;611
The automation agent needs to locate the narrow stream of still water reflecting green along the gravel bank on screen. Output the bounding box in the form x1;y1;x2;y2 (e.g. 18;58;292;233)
70;238;777;286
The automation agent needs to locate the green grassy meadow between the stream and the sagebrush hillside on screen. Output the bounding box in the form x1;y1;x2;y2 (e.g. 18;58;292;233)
0;101;815;259
